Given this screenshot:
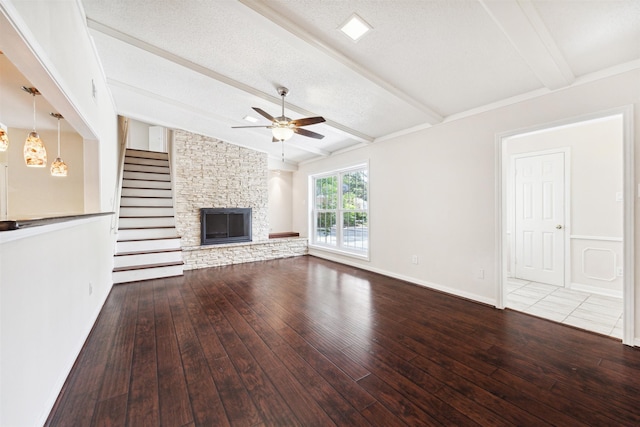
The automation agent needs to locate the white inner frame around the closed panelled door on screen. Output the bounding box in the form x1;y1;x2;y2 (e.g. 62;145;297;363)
504;149;571;288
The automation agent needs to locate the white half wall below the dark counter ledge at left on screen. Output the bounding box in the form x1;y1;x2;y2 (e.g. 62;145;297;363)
0;215;113;427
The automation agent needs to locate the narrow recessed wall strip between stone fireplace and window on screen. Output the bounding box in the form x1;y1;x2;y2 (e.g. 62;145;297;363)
269;171;297;233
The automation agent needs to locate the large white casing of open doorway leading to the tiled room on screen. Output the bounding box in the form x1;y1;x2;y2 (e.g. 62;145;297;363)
495;105;640;346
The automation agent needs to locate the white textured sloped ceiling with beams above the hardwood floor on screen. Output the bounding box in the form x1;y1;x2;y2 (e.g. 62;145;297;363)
3;0;640;164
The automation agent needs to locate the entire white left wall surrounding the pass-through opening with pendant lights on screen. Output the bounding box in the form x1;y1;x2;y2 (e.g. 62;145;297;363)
0;0;118;426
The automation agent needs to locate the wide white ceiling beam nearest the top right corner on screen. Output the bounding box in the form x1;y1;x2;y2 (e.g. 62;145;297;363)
478;0;575;90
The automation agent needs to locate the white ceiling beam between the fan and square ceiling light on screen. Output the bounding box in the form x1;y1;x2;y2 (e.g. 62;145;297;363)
238;0;444;125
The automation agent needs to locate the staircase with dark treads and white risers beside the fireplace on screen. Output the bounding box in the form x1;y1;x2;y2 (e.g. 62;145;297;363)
113;149;184;284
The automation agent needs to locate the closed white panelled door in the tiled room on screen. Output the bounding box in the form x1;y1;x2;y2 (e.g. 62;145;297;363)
514;153;565;286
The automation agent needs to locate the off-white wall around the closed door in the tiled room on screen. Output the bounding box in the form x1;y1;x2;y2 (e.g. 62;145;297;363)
507;115;623;296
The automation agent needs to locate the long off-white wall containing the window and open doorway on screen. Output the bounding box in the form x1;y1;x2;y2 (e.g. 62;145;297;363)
293;70;640;314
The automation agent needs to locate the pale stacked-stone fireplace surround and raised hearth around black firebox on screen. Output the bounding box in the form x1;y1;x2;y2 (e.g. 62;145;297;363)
171;130;307;270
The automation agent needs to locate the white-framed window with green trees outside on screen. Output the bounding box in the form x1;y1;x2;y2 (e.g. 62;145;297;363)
311;166;369;256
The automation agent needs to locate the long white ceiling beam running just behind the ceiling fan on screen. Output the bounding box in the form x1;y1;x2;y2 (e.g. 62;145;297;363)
87;18;374;143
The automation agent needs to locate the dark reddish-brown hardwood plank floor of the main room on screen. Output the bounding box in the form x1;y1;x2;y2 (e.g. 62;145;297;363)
47;256;640;426
